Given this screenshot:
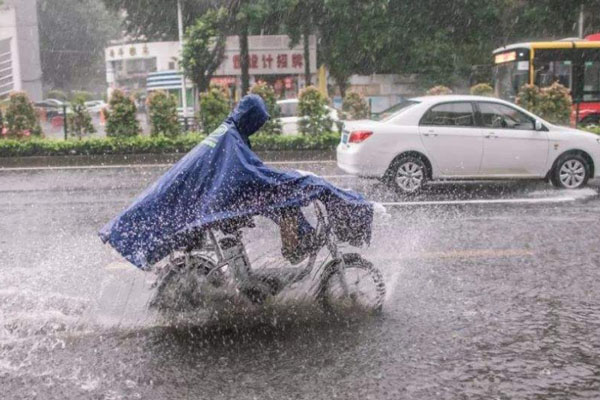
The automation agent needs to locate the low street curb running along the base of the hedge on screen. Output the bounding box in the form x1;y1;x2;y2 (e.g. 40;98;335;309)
0;150;335;168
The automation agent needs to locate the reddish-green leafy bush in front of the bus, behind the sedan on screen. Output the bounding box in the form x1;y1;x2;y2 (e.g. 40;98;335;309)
517;82;573;125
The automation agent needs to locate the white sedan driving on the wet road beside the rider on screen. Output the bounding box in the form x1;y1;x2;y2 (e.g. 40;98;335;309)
337;95;600;194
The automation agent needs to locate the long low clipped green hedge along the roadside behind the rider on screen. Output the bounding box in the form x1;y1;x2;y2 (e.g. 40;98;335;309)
0;133;340;157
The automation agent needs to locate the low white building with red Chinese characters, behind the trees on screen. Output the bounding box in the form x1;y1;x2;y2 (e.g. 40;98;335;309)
105;35;317;104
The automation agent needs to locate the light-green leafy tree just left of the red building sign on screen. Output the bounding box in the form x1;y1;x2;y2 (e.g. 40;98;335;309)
181;8;227;92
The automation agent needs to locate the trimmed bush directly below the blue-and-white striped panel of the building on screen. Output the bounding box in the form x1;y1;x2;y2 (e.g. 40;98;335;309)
146;90;179;137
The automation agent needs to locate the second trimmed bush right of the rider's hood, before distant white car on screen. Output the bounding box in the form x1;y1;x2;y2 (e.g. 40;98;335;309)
298;86;333;135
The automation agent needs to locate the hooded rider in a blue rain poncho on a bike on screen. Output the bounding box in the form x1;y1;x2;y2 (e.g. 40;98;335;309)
99;95;373;269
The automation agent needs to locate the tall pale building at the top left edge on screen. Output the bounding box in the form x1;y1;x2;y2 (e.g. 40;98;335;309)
0;0;42;101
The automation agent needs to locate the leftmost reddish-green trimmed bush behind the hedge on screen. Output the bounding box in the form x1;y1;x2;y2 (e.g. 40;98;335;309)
6;92;42;137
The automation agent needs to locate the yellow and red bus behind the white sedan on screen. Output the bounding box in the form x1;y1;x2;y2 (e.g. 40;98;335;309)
493;33;600;125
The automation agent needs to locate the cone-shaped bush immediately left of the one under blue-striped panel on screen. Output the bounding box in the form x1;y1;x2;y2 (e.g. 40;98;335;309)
104;89;141;137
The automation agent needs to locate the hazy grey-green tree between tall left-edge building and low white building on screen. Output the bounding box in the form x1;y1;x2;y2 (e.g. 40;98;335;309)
38;0;121;89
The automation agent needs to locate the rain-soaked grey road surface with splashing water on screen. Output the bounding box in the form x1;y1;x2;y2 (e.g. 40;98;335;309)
0;162;600;399
